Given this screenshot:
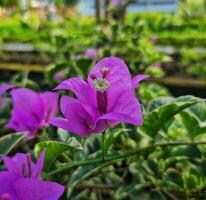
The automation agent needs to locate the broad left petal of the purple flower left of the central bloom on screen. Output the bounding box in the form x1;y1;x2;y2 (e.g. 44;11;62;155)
7;88;44;138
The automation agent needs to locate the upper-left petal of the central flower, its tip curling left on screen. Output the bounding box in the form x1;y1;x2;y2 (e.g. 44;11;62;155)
55;78;97;116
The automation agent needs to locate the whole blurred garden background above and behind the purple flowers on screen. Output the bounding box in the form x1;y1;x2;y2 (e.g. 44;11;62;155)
0;0;206;102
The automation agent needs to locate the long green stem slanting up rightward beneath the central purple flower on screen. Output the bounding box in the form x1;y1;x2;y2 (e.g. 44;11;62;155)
48;141;206;177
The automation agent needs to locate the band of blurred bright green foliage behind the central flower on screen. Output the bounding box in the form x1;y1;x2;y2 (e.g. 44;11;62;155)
0;13;206;79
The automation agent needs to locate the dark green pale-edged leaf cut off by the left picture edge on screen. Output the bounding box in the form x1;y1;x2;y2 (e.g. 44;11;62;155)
0;133;25;155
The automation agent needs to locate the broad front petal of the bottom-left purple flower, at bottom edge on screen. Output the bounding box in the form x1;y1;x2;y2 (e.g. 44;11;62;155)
13;178;64;200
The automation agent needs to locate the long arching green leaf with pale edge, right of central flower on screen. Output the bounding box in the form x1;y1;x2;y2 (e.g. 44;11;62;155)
140;96;198;137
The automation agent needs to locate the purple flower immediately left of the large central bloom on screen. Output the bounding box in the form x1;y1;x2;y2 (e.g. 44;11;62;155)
7;88;58;139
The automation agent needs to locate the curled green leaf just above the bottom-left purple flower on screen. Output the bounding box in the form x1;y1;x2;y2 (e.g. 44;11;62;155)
34;137;83;170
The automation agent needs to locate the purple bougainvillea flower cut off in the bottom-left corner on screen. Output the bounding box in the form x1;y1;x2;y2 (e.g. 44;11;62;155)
0;151;64;200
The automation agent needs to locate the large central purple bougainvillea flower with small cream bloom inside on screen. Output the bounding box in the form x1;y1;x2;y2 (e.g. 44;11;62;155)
50;57;148;136
